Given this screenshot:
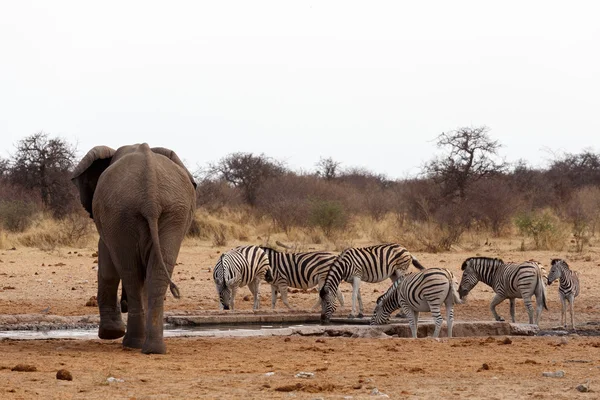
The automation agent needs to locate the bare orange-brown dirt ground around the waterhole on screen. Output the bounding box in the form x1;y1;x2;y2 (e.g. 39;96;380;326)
0;240;600;399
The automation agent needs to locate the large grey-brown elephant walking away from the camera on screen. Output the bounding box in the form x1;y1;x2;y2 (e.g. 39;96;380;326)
72;143;196;354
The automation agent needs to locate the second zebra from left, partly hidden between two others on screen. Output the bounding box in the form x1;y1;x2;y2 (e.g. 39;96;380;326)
262;247;344;310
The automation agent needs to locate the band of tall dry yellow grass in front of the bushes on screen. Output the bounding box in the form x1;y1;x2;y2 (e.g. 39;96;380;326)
0;208;574;253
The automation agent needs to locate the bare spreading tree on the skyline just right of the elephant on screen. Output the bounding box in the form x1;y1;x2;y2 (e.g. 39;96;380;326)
208;153;285;206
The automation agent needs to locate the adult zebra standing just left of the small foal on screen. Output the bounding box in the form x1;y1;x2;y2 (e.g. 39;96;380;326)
458;257;548;324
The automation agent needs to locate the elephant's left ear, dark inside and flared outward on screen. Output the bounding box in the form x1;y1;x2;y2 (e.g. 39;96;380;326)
71;146;115;218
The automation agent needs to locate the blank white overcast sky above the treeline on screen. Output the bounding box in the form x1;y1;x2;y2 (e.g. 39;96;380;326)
0;0;600;178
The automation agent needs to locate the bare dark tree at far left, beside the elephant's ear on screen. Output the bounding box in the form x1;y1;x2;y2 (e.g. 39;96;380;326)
10;132;76;216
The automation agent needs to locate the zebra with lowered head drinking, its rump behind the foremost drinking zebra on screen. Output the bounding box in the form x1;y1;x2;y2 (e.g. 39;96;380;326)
319;244;424;321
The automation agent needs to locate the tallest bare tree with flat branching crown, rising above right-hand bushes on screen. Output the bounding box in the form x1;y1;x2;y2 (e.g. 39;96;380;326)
425;126;507;199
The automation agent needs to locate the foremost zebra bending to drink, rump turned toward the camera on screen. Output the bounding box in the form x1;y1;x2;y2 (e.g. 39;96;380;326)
371;268;462;338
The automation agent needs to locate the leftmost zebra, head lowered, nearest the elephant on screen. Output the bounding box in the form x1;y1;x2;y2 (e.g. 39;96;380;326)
213;246;270;310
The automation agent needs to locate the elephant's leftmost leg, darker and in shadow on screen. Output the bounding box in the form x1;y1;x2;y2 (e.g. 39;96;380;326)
98;239;125;340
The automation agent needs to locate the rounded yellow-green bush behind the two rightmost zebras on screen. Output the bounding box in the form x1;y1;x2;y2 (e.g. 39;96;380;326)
515;209;567;250
